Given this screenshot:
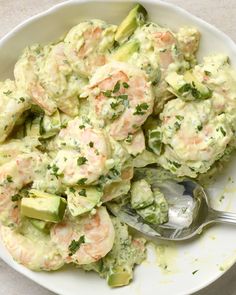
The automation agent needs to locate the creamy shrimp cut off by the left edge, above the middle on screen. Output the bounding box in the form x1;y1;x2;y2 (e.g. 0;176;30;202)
0;79;30;142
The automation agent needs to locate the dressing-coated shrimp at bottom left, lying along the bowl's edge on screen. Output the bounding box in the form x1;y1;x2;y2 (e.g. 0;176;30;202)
1;223;65;271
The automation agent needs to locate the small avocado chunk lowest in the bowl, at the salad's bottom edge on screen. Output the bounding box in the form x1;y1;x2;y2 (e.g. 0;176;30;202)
107;267;132;288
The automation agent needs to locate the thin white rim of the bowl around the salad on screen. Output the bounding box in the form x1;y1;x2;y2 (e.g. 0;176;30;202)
0;0;236;295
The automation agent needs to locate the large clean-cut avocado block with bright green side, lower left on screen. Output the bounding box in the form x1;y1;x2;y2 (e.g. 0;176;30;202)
21;196;67;222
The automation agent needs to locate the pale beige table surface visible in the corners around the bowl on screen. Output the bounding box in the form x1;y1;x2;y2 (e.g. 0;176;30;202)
0;0;236;295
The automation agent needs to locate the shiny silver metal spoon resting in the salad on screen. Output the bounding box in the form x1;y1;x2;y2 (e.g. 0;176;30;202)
109;179;236;241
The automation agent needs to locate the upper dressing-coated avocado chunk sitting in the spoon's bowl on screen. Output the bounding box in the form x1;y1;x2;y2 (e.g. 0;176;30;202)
131;179;154;209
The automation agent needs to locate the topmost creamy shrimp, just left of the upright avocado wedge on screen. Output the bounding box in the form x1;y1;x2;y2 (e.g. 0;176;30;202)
65;20;117;77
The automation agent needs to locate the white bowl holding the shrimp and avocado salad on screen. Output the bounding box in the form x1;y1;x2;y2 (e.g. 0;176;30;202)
0;0;236;295
